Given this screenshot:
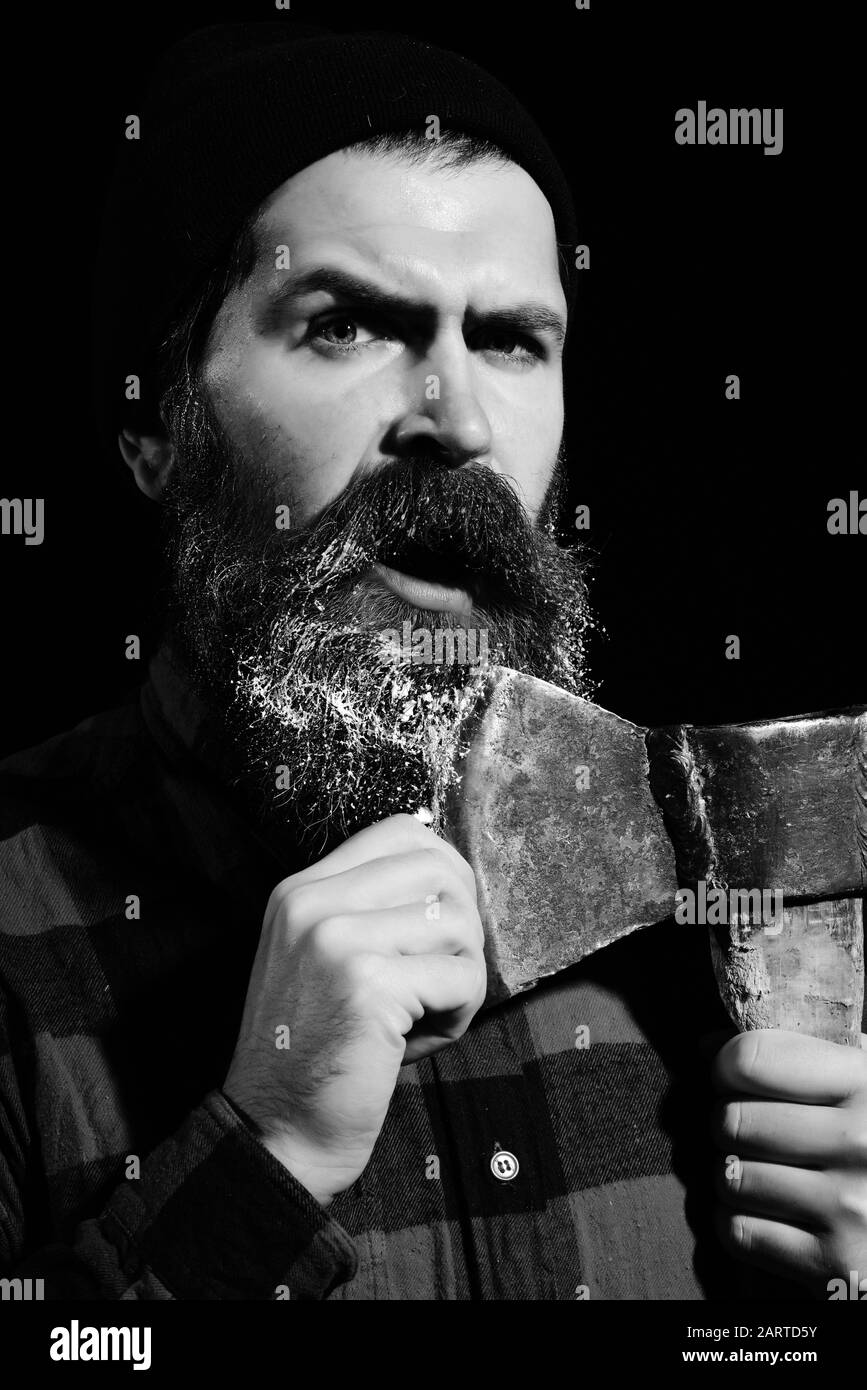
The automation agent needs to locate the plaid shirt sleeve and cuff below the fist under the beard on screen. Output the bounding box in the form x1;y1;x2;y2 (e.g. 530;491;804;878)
0;1055;357;1301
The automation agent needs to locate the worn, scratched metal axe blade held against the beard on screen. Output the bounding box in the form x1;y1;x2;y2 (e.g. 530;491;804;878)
446;667;677;1004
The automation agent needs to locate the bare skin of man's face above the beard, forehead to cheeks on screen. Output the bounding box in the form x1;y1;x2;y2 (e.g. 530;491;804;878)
203;152;565;547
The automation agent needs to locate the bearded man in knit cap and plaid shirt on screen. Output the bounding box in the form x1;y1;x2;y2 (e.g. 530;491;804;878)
0;25;867;1300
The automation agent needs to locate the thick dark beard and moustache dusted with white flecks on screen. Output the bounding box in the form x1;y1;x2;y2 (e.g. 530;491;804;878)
157;375;593;859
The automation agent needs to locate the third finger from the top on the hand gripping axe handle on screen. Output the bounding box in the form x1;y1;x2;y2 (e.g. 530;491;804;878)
717;1156;835;1230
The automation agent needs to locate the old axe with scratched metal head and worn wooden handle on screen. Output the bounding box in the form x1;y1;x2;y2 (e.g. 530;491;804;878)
445;667;867;1047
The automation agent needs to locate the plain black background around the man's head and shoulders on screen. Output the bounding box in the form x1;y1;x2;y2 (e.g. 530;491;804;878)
0;0;867;752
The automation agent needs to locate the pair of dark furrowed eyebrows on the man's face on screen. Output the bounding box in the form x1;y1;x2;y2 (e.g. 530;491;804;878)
263;265;565;346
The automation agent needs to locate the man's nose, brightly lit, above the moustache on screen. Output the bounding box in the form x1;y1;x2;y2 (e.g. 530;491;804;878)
383;331;493;468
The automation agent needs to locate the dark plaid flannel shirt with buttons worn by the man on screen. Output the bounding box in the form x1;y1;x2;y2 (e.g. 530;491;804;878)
0;651;816;1300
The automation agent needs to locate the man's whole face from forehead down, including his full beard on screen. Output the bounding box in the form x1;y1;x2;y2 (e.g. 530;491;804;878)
157;152;589;849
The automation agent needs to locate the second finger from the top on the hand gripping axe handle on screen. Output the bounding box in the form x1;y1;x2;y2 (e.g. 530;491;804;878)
711;1098;867;1168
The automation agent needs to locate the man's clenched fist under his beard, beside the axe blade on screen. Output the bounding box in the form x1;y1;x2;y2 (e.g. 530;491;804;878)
224;816;486;1204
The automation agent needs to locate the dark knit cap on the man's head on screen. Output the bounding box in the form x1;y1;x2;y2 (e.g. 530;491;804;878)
94;18;577;439
